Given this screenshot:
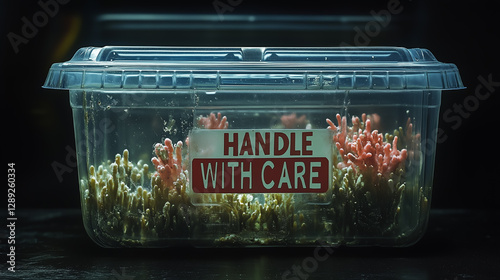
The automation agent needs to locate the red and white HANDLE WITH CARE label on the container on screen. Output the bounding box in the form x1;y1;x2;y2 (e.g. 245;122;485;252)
189;129;333;193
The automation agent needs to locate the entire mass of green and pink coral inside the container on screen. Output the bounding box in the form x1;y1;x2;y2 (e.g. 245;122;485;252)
81;113;428;246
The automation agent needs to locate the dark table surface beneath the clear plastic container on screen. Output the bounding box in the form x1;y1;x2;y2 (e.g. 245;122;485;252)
0;209;500;280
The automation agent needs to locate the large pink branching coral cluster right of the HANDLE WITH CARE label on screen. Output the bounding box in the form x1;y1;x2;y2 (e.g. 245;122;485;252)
326;114;408;178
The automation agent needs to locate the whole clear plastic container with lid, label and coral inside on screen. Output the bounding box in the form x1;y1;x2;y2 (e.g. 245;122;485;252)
44;47;463;247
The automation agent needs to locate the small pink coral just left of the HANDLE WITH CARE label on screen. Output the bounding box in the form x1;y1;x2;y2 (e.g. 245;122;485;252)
151;138;184;189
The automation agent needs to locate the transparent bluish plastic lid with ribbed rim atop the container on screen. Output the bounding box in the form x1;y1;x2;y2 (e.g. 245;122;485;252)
44;46;463;90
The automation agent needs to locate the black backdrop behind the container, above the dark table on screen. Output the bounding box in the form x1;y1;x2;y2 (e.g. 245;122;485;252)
0;0;500;210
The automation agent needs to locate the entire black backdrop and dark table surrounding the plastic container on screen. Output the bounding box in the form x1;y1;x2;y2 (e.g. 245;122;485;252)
0;0;500;280
